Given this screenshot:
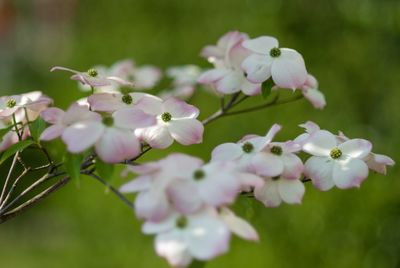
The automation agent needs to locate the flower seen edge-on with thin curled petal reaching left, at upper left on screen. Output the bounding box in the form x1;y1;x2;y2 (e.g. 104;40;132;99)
50;66;134;88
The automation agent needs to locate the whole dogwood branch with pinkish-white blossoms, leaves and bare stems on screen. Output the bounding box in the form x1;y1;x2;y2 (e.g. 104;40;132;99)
0;32;394;267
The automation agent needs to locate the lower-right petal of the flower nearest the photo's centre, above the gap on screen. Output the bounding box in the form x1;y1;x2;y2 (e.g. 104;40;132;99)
168;119;204;145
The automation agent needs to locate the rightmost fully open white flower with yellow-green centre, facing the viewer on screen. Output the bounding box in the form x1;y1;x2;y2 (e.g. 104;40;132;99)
303;130;372;191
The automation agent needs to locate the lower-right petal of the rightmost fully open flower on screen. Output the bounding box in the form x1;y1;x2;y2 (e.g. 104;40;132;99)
333;158;368;189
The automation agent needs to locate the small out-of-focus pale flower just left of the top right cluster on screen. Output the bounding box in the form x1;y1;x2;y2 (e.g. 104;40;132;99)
159;65;201;100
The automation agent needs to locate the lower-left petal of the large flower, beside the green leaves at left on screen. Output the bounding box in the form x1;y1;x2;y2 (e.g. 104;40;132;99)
61;122;104;153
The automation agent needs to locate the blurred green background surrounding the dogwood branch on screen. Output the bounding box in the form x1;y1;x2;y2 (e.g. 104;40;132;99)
0;0;400;268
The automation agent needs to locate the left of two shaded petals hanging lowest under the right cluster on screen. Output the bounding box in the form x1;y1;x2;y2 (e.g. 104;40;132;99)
254;179;282;207
